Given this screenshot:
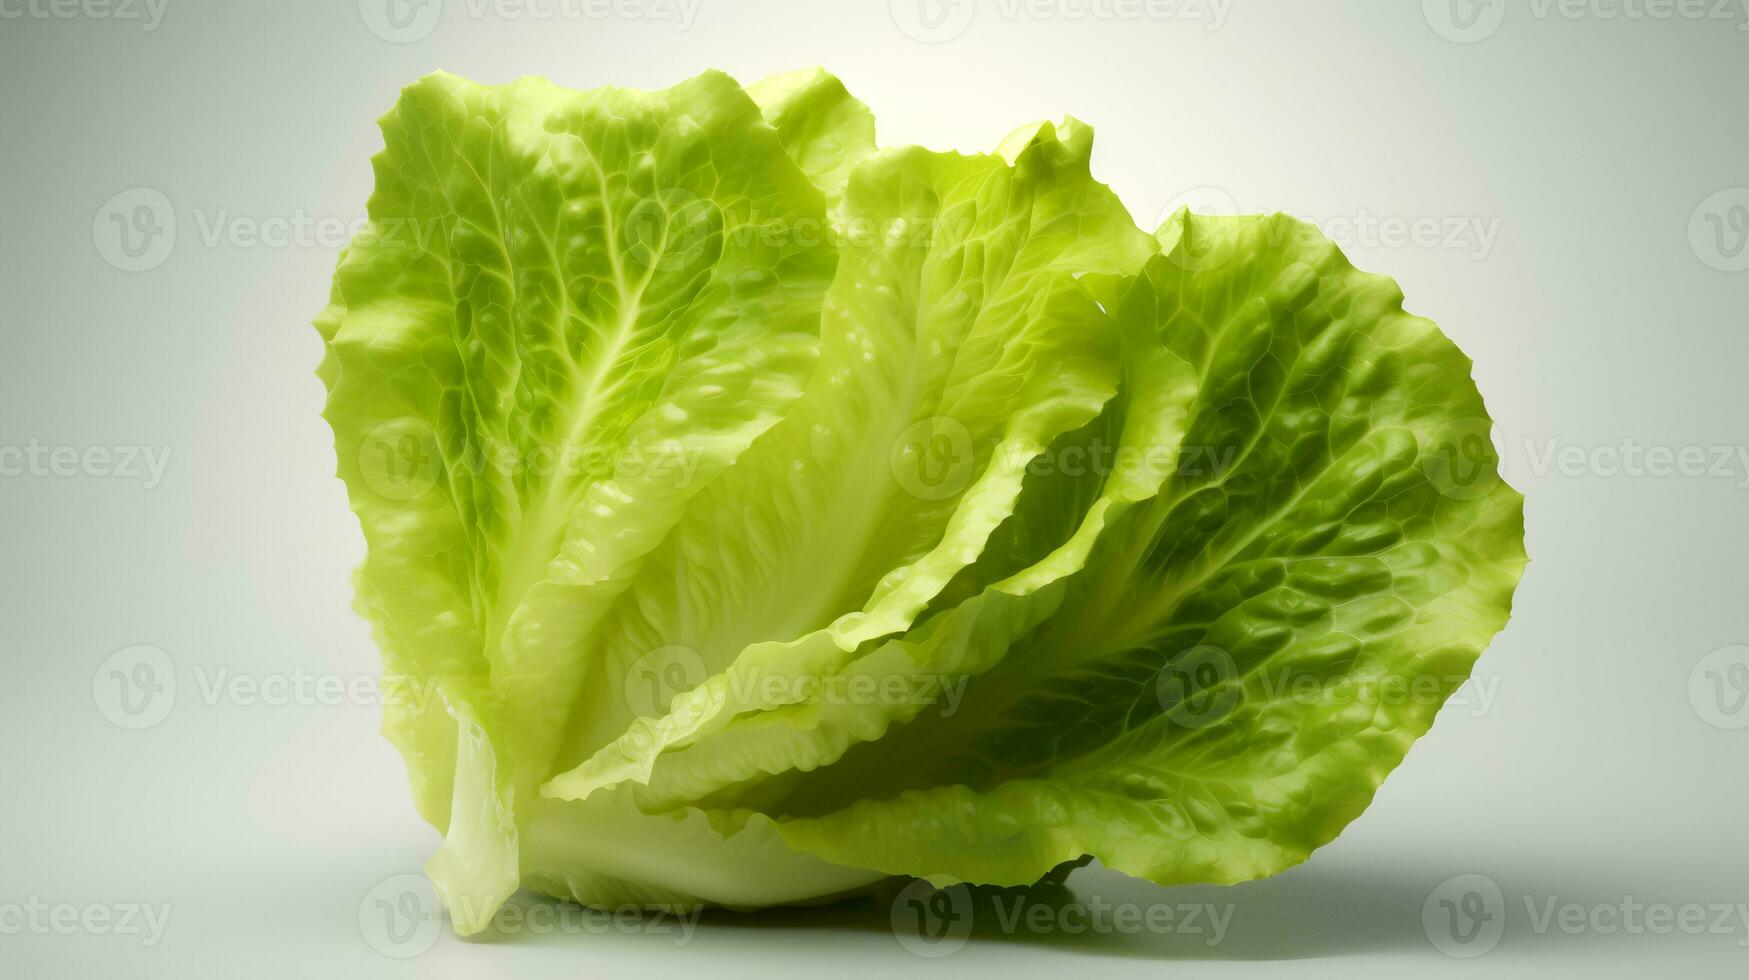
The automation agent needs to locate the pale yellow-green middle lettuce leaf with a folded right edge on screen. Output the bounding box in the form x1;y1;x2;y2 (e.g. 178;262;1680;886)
546;124;1156;798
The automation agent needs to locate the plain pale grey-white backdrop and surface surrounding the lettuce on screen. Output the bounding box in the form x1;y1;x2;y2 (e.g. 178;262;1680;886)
0;0;1749;978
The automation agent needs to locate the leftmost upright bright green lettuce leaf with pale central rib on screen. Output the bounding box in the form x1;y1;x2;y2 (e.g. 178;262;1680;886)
318;74;836;929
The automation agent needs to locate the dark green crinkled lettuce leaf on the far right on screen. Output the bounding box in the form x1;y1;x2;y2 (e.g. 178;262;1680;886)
764;214;1525;884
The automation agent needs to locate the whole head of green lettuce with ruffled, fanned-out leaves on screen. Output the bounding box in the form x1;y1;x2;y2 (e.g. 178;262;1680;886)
317;72;1525;933
